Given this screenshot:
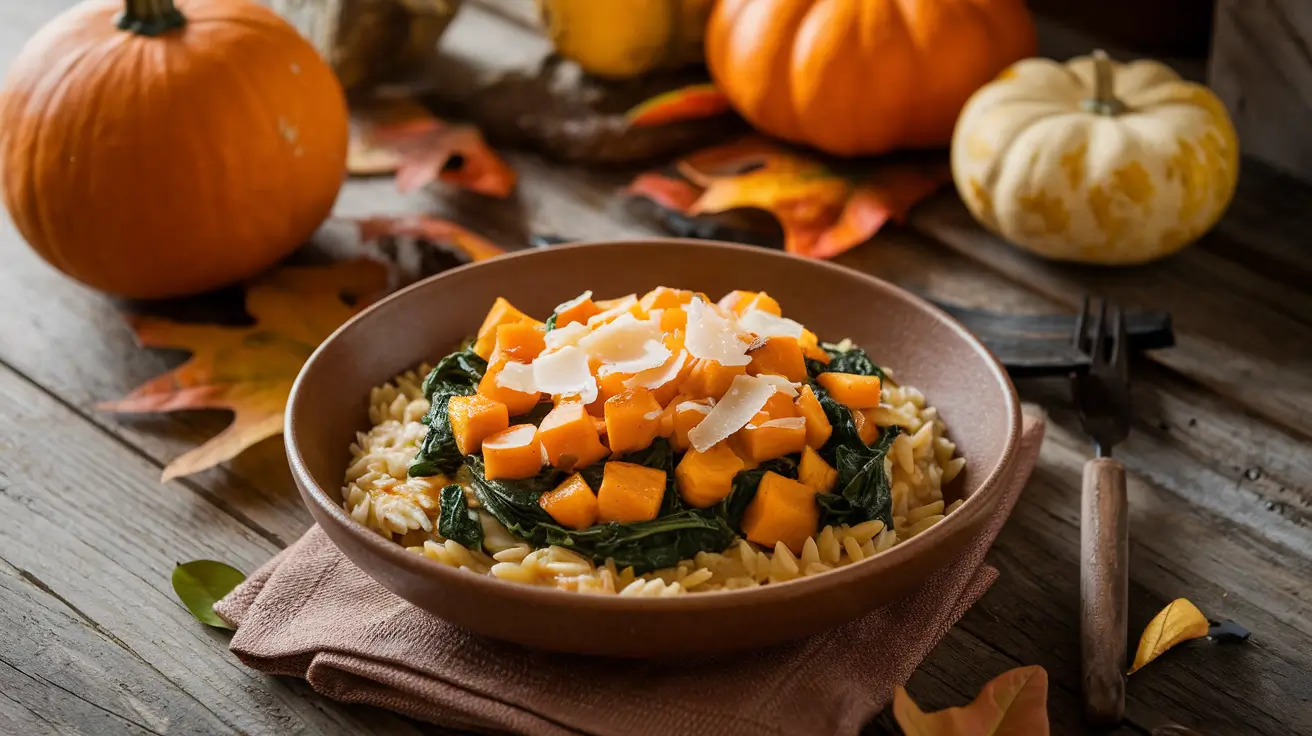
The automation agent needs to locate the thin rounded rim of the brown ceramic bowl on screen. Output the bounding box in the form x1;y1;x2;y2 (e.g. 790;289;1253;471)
283;236;1021;613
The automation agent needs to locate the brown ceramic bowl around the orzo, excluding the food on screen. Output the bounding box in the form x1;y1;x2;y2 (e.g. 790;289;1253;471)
286;240;1021;657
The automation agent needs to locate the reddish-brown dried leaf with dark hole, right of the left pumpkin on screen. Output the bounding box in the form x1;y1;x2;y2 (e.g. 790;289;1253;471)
346;101;516;197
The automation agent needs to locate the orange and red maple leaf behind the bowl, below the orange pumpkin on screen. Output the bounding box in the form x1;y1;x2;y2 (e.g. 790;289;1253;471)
627;138;949;258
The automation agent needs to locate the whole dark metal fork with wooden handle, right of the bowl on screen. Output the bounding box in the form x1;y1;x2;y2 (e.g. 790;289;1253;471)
1071;296;1131;726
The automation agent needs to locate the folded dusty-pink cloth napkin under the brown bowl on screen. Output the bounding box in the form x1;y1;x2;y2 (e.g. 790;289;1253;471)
214;415;1043;736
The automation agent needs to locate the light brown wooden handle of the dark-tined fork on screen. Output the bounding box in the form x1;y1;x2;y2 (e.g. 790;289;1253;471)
1080;458;1130;726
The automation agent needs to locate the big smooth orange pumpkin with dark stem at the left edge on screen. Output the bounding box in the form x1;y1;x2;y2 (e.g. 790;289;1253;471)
0;0;348;298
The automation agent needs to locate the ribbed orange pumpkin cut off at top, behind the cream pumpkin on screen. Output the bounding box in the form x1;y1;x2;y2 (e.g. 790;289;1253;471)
706;0;1035;156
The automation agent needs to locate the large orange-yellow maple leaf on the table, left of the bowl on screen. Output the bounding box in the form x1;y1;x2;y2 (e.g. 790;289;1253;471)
97;258;387;481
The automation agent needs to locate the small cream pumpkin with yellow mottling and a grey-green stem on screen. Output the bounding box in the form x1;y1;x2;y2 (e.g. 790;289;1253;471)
953;51;1239;265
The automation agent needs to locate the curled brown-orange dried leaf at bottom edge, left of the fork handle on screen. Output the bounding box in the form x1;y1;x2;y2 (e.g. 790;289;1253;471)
893;666;1048;736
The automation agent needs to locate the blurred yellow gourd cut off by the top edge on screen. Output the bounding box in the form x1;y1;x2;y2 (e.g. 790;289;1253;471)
538;0;714;79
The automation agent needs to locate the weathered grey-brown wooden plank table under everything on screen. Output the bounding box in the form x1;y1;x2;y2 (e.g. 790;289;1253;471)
0;0;1312;735
